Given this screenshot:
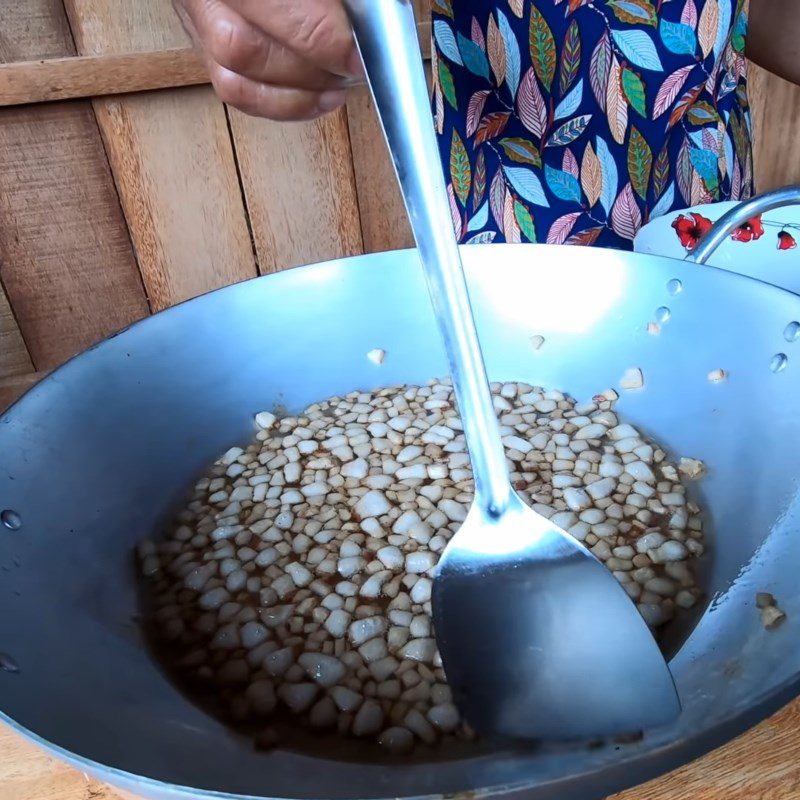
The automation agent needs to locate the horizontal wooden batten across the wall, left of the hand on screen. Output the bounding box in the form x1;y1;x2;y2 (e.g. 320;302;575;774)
0;47;208;106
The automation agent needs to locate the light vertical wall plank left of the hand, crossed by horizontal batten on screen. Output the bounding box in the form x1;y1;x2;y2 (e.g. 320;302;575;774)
66;0;256;309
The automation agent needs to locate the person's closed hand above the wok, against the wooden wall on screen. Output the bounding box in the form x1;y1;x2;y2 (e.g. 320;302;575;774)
174;0;363;120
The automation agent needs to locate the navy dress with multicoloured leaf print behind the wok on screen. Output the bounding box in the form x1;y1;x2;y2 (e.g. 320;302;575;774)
433;0;753;249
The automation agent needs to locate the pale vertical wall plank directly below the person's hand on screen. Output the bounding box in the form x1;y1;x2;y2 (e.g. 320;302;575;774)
229;109;363;273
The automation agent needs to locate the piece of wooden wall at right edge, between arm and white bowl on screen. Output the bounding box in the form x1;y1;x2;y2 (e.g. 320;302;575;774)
749;64;800;192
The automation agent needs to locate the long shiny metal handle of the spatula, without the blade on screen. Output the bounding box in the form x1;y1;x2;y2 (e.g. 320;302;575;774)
345;0;510;515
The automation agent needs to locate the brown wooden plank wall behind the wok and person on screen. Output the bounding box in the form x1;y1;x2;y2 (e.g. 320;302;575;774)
0;0;800;408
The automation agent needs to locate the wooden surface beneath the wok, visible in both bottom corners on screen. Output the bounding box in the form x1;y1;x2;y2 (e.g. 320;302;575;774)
0;700;800;800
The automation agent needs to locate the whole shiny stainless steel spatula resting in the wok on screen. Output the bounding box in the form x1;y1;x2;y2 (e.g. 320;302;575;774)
345;0;680;739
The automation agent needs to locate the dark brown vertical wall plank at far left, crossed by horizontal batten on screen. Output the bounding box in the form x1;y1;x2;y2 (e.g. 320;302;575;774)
0;0;148;371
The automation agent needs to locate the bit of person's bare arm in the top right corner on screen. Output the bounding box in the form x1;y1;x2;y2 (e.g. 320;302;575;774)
746;0;800;84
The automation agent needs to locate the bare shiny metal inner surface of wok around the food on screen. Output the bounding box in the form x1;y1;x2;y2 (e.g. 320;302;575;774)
0;245;800;798
